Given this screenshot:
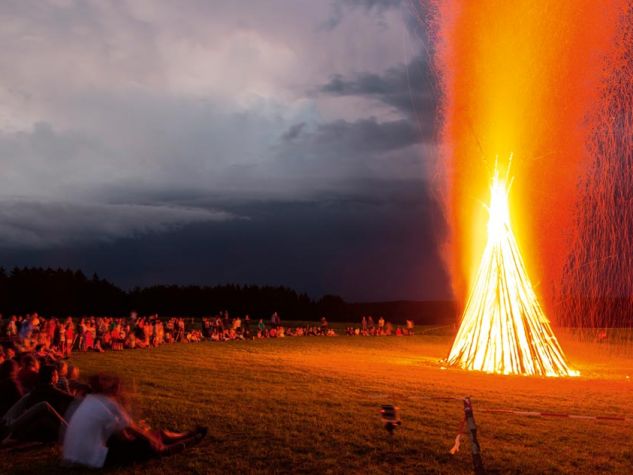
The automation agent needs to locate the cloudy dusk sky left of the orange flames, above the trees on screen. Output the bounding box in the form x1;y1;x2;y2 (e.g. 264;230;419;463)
0;0;450;301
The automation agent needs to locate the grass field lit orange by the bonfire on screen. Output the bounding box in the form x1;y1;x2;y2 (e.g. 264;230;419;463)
0;332;633;474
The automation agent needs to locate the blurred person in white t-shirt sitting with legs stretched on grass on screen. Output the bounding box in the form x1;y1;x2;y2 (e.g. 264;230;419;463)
62;374;207;468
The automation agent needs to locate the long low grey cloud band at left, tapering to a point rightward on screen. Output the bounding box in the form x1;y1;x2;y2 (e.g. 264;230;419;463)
0;200;235;249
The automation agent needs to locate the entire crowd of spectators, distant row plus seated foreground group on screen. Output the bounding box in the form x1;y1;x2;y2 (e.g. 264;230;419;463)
0;312;413;468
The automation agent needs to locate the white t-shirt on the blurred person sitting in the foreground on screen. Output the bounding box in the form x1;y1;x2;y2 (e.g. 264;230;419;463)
63;394;131;468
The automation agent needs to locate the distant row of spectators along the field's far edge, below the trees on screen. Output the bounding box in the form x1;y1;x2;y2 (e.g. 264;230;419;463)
0;311;413;361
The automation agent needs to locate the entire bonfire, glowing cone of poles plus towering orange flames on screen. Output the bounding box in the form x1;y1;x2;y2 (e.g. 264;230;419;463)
430;0;633;375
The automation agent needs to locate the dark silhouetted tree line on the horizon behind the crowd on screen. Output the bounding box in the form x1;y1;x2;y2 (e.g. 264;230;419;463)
0;267;452;323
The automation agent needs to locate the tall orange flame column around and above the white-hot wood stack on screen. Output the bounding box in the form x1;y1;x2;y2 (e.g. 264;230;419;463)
434;0;627;316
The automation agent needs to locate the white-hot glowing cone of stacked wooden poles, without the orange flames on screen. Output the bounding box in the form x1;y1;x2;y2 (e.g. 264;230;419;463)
448;162;578;376
